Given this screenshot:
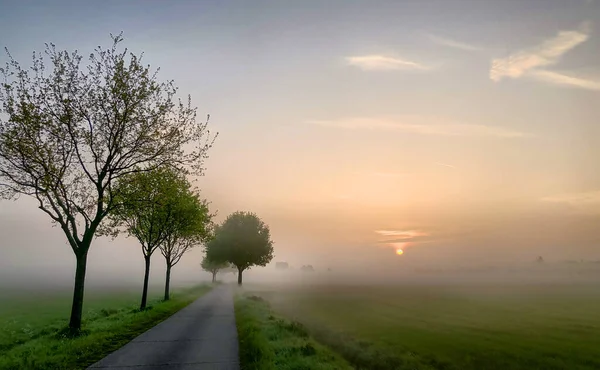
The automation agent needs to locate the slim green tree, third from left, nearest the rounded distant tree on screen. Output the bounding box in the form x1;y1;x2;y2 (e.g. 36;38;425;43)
158;188;214;301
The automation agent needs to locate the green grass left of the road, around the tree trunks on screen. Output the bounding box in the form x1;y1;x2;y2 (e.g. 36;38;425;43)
0;285;210;370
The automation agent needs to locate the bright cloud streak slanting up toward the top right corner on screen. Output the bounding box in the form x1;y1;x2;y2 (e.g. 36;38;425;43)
490;23;590;81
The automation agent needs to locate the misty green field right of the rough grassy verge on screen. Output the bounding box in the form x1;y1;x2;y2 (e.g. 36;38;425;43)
248;284;600;370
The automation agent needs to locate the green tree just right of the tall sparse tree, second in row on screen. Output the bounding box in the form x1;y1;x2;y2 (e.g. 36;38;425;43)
109;167;197;310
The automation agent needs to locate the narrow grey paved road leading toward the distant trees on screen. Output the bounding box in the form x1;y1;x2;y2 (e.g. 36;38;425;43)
88;286;240;370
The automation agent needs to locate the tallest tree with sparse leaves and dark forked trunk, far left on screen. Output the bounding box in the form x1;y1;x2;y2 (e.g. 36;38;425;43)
0;35;216;333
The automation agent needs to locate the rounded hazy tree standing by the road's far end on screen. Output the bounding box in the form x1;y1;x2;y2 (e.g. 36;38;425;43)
206;212;273;285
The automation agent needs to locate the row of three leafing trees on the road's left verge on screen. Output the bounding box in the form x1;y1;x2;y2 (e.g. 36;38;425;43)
0;35;216;333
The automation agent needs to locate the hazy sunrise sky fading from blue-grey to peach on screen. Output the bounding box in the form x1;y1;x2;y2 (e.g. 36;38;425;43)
0;0;600;286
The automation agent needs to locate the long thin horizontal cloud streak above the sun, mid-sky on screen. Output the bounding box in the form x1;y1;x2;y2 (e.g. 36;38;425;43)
308;116;531;138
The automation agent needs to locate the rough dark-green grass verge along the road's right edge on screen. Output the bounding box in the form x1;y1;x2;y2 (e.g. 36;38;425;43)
235;296;351;370
